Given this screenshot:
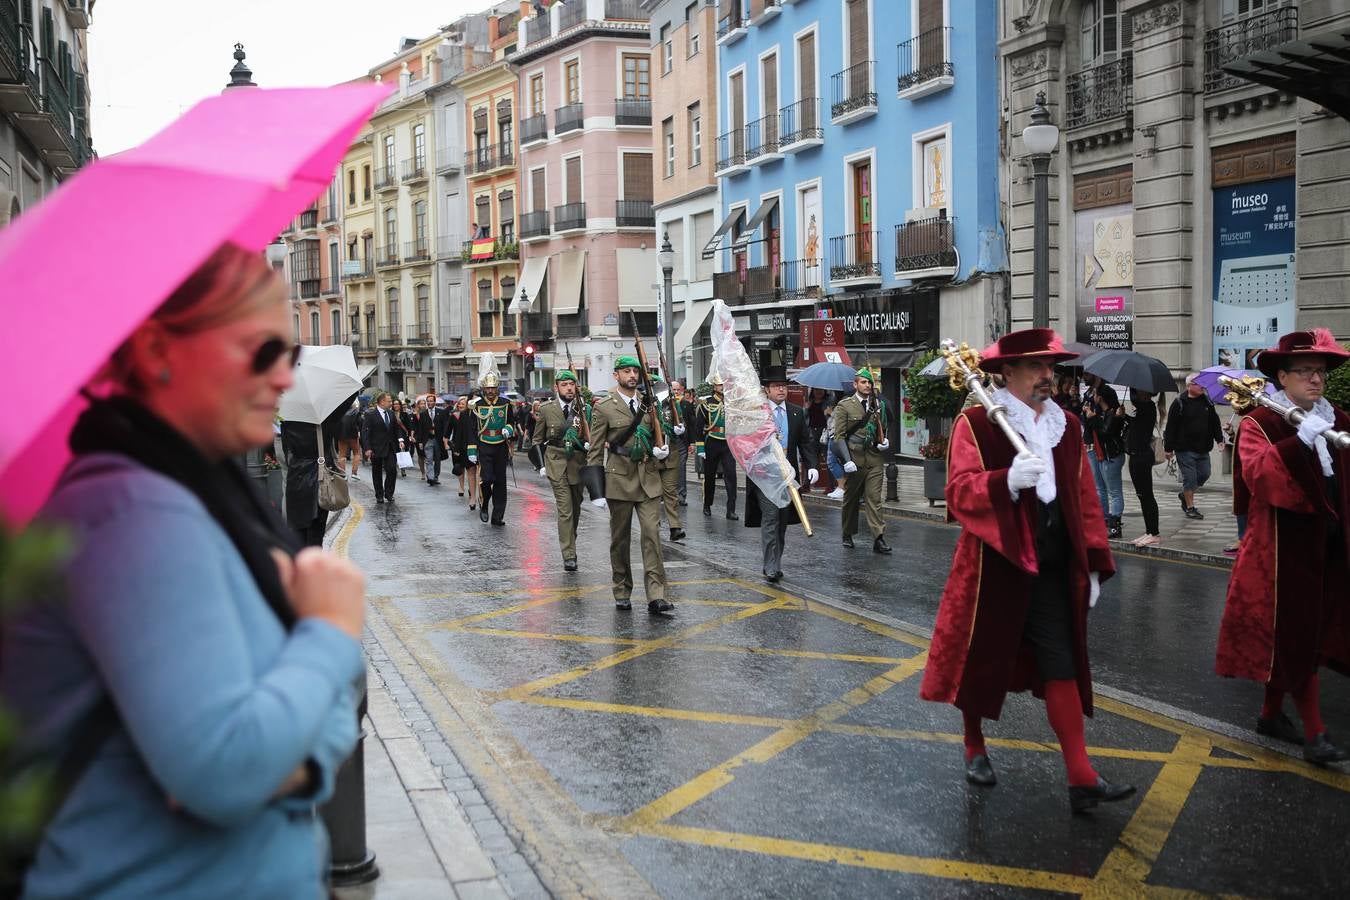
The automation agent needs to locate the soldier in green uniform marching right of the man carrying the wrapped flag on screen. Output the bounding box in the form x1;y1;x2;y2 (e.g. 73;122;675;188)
832;367;891;553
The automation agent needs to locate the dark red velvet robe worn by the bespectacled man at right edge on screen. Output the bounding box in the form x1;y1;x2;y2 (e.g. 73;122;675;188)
1215;409;1350;691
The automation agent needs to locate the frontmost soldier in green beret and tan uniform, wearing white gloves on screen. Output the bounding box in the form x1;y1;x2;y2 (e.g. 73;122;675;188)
589;356;675;613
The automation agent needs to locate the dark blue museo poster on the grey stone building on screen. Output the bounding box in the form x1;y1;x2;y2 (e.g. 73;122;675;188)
1214;177;1296;370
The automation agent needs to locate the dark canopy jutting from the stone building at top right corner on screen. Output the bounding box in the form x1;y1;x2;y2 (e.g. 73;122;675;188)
1223;26;1350;119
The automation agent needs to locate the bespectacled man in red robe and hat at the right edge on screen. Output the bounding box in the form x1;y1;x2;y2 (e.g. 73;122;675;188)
1215;328;1350;765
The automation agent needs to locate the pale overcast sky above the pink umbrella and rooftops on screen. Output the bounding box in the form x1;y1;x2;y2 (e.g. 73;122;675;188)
89;0;490;157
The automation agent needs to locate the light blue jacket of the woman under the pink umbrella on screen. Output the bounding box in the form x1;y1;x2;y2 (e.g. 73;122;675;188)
0;455;363;900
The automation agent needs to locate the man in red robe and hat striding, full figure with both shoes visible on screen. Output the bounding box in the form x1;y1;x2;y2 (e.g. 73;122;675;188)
919;328;1134;812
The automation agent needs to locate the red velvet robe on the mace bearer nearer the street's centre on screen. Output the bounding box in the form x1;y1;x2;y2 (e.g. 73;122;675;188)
919;406;1115;719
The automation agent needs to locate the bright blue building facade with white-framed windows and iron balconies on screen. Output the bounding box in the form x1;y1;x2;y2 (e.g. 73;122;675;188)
705;0;1007;449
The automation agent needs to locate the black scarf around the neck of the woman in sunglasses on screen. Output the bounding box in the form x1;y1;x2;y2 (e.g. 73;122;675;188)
70;397;301;630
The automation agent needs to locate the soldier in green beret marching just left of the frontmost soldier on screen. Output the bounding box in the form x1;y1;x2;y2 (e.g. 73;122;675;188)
528;368;590;572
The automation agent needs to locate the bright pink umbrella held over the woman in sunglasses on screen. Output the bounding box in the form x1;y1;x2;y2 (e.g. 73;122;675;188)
0;84;392;524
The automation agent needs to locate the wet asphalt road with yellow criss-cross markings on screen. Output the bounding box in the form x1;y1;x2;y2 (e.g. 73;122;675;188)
348;457;1350;897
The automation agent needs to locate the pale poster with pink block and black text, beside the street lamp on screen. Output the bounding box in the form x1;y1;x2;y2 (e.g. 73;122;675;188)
1073;204;1134;349
